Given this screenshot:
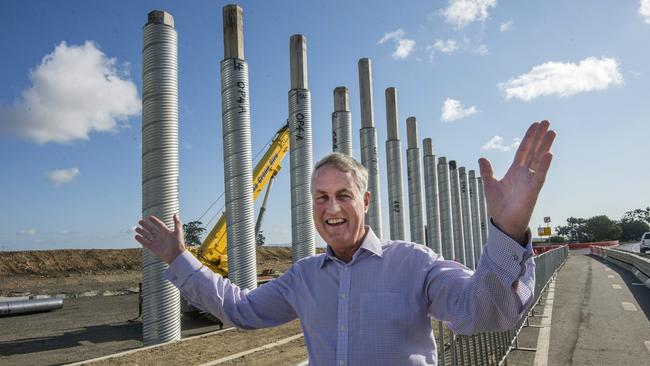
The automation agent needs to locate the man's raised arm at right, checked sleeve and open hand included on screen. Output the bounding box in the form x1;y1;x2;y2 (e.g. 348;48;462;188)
427;121;556;333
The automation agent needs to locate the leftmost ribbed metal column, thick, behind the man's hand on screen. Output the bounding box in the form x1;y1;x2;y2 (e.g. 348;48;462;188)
142;10;180;346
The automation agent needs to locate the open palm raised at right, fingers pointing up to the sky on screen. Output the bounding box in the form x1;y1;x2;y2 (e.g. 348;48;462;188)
479;121;556;242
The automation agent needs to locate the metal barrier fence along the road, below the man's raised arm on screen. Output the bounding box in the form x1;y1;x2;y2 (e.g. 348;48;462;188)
437;246;569;366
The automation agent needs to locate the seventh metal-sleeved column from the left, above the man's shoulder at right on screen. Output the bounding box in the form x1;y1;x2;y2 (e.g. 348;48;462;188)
406;117;426;244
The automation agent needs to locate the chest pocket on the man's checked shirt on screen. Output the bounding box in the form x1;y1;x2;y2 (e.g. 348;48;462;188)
359;292;408;344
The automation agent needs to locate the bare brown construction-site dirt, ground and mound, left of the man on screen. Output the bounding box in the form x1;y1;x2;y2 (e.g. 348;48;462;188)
0;247;307;365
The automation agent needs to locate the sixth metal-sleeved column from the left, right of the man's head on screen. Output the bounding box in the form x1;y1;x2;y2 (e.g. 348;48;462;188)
386;88;405;240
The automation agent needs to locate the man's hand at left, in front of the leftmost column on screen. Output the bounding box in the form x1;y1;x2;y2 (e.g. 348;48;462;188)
135;214;185;264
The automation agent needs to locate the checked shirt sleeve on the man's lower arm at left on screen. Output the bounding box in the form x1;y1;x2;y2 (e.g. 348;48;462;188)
164;251;297;329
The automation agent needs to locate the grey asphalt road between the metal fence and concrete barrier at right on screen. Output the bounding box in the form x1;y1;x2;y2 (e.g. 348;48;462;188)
548;252;650;365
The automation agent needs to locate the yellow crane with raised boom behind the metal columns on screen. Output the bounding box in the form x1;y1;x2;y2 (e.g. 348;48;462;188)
188;123;290;277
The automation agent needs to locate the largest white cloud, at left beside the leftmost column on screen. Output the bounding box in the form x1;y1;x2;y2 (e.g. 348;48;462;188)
0;41;140;144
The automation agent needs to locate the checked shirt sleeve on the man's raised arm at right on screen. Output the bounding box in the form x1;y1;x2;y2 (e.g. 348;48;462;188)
425;222;535;334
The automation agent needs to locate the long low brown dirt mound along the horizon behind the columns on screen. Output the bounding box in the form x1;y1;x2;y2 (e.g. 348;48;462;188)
0;247;298;277
